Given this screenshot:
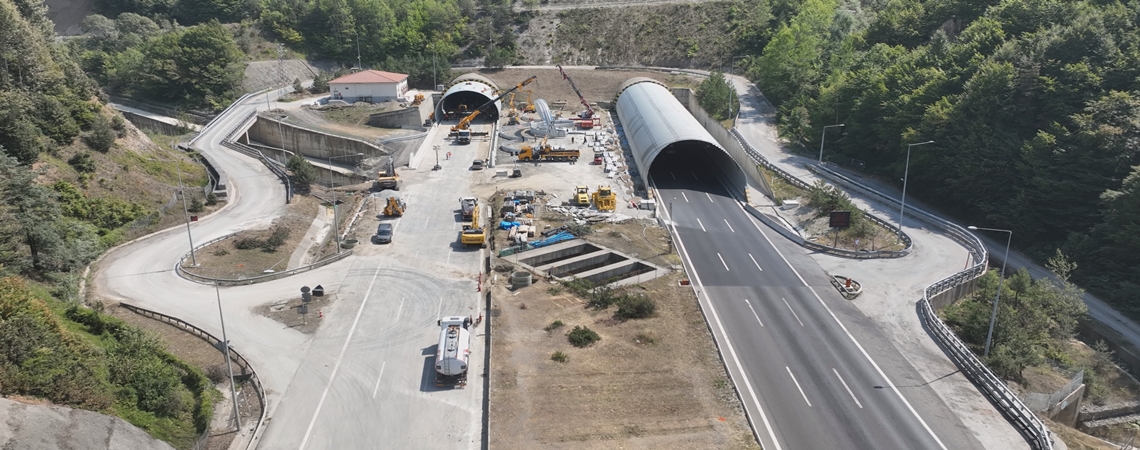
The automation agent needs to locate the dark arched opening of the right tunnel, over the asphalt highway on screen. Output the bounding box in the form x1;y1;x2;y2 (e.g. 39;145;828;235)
649;140;744;198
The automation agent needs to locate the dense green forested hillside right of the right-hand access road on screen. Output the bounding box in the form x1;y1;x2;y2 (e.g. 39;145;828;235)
741;0;1140;317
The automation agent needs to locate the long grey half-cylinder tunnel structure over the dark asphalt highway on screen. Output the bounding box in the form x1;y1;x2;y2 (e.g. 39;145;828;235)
617;76;747;194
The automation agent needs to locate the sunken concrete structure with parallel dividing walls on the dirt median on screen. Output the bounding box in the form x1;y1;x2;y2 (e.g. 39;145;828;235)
512;239;668;286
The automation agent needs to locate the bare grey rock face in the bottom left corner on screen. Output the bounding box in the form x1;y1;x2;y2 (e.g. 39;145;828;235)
0;399;173;450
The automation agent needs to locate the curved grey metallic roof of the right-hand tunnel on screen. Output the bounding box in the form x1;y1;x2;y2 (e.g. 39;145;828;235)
617;77;727;186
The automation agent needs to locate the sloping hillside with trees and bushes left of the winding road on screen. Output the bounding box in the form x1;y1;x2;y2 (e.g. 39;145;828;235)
0;0;214;448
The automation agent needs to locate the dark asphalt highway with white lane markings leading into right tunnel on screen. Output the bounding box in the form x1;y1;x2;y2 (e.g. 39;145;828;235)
652;161;982;449
